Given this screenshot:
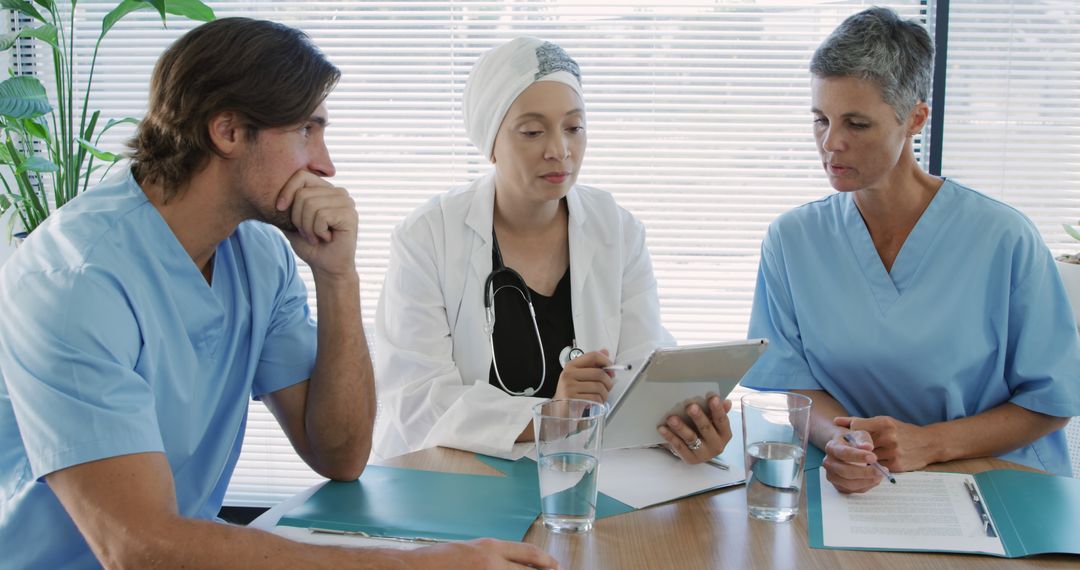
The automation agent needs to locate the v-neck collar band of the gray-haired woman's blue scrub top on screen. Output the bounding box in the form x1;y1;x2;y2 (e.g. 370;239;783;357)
840;180;955;313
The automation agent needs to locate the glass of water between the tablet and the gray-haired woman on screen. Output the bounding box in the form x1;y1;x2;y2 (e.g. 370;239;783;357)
742;392;811;523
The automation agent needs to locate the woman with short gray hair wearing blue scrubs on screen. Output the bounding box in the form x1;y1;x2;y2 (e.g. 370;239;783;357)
743;8;1080;492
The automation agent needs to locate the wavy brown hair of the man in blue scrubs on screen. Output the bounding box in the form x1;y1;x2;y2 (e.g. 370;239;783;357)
127;17;341;200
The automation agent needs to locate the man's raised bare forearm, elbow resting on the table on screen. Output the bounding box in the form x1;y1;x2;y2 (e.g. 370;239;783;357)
305;273;376;479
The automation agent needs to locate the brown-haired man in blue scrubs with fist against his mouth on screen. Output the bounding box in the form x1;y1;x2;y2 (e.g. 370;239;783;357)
0;18;555;568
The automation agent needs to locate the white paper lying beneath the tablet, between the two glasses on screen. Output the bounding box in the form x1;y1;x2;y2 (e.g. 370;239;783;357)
597;448;746;508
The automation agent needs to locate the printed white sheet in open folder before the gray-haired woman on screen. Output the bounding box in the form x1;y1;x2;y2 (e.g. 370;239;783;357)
818;470;1005;555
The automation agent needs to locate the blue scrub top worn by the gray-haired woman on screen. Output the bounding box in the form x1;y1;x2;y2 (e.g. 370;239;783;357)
743;180;1080;475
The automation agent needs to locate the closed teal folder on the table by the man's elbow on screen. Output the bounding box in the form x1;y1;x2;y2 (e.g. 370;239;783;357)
278;465;540;541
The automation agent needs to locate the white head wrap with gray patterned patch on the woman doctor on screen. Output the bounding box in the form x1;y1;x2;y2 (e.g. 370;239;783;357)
464;37;581;159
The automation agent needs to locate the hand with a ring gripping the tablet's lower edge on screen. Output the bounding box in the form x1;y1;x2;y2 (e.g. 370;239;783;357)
657;394;731;464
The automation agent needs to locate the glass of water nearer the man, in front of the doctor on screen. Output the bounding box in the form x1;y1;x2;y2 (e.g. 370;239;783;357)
532;399;607;533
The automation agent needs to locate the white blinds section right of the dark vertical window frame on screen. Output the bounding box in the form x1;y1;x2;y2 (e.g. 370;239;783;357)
942;0;1080;254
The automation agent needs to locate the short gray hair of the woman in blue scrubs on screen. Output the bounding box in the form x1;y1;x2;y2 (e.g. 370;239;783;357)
810;6;934;122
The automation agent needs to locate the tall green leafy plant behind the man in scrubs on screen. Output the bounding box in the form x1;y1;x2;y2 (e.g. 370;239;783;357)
0;0;214;245
